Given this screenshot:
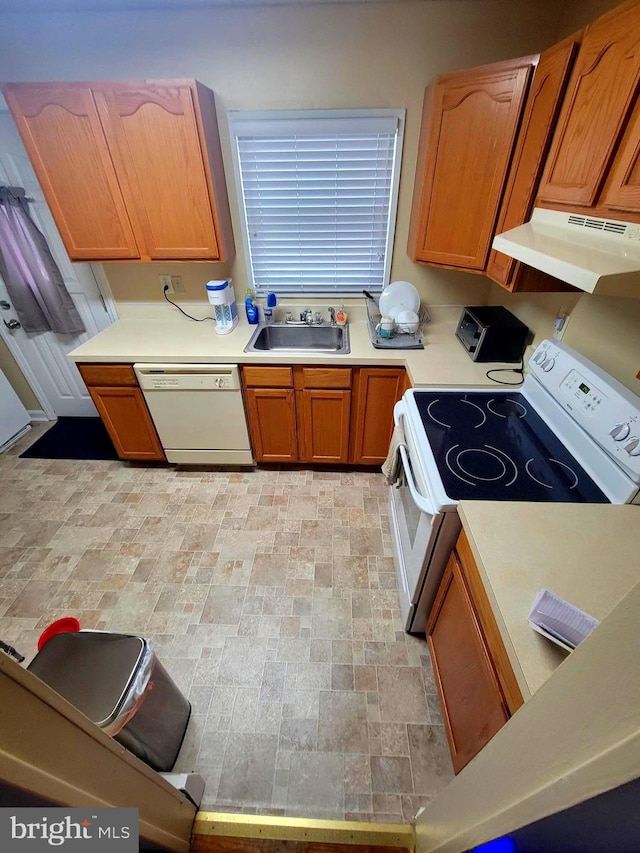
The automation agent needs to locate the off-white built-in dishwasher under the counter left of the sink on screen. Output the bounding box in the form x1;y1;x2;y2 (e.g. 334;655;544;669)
133;364;254;465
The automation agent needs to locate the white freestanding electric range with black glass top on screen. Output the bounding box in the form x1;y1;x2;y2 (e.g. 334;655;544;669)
389;340;640;633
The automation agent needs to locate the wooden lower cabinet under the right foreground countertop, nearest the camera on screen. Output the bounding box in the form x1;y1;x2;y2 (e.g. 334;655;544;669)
427;531;523;773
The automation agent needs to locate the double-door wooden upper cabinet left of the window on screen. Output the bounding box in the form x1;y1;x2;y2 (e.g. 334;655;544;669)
3;80;234;261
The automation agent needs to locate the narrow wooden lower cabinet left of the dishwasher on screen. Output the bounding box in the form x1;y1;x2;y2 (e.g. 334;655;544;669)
78;364;165;462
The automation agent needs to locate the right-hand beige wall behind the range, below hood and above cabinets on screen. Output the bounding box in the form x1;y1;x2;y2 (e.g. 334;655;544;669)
488;0;640;395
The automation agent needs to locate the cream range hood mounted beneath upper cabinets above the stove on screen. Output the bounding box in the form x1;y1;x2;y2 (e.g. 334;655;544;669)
493;207;640;298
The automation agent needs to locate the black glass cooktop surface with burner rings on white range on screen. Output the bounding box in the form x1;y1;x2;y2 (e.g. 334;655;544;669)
415;391;609;503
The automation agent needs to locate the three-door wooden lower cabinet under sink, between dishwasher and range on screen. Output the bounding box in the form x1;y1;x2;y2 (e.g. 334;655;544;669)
242;366;407;465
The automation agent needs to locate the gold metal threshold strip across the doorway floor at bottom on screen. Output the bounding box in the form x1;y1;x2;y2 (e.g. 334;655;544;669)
193;812;415;850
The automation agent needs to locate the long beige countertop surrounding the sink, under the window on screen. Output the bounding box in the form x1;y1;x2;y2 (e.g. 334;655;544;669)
69;303;517;386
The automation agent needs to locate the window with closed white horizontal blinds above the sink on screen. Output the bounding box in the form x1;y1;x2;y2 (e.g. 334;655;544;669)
229;110;404;296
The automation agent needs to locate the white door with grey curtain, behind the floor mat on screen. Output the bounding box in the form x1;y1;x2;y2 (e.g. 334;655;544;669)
0;112;112;419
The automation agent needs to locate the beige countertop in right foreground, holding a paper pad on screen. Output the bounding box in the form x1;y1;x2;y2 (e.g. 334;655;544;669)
459;501;640;701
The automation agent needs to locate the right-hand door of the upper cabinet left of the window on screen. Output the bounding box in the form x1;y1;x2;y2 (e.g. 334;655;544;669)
94;84;220;260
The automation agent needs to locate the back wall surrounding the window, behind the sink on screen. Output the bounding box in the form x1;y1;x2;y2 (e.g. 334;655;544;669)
0;0;559;312
